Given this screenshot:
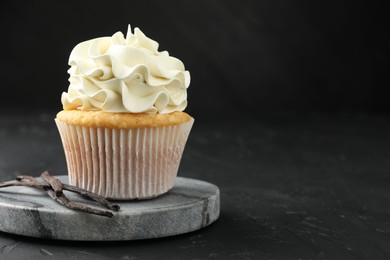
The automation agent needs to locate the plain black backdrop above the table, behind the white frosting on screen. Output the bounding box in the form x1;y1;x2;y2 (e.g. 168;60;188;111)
0;0;390;118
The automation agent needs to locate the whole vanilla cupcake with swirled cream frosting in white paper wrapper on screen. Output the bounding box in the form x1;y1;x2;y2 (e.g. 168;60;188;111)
55;26;194;200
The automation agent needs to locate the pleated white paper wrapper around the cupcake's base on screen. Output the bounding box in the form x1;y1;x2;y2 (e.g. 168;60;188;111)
55;118;194;200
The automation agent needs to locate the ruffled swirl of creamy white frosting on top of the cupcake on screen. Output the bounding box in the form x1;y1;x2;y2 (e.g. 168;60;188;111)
61;26;190;114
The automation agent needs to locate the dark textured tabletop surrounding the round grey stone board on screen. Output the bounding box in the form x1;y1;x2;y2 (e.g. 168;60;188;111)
0;111;390;259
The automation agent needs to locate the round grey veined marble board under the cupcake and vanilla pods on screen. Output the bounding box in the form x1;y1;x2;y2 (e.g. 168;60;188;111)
0;176;220;241
